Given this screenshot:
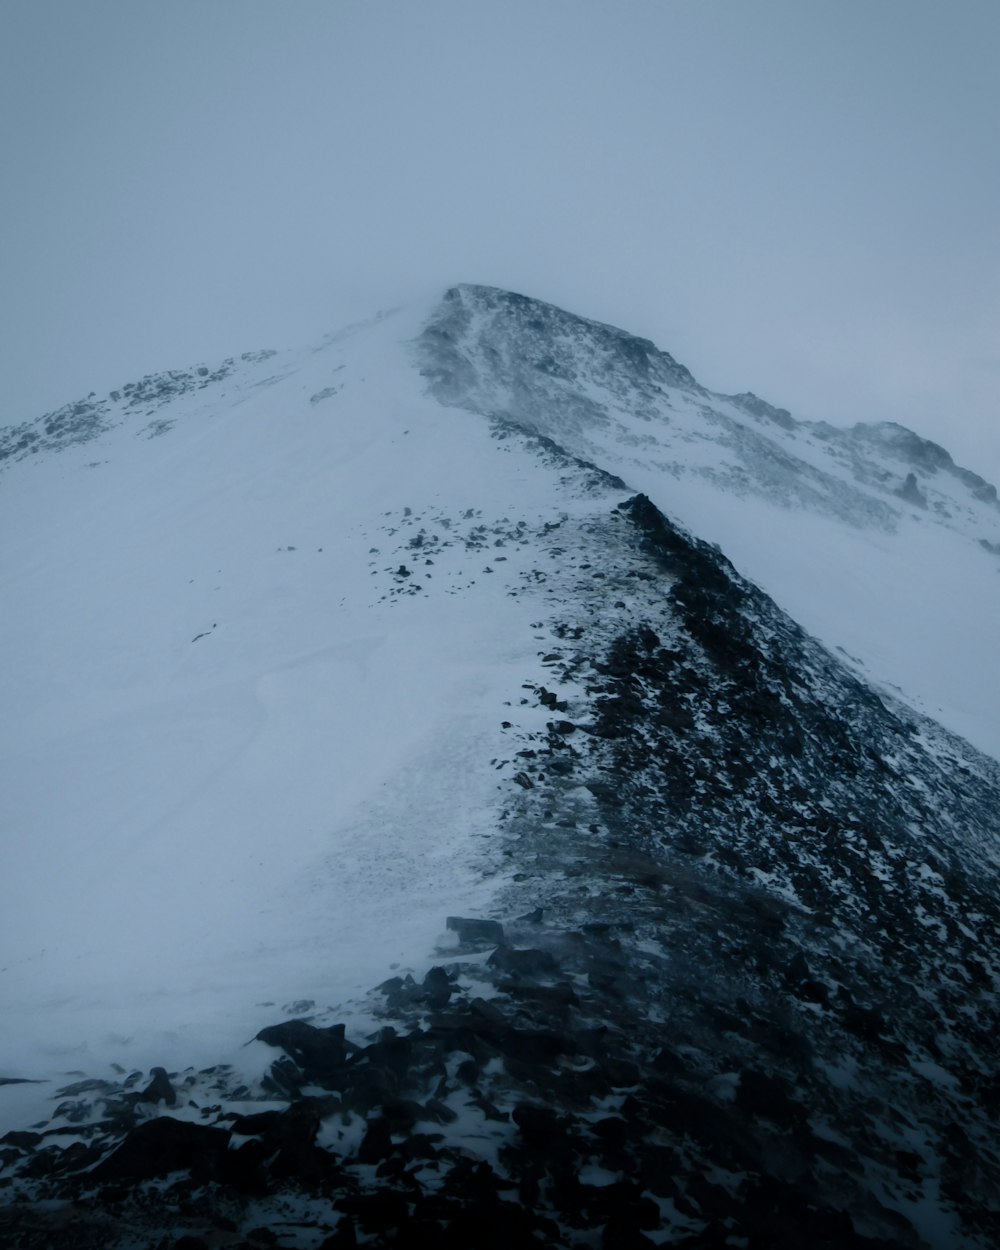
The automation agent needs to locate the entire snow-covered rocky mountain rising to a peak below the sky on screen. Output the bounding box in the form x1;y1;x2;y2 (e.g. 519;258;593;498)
0;286;1000;1250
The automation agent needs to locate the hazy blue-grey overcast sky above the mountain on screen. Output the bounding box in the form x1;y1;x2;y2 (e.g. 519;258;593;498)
0;0;1000;481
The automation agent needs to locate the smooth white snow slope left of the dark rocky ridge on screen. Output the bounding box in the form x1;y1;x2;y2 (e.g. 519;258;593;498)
0;300;625;1074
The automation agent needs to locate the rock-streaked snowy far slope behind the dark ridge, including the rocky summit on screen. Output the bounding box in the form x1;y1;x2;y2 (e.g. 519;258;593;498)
423;286;1000;759
